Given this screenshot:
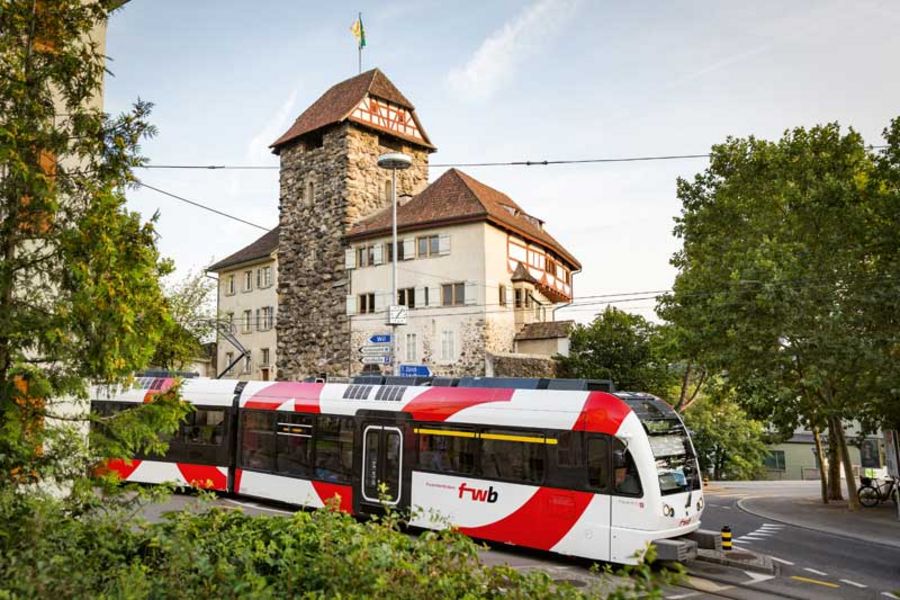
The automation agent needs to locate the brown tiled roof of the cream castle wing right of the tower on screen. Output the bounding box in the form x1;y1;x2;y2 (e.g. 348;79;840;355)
347;169;581;269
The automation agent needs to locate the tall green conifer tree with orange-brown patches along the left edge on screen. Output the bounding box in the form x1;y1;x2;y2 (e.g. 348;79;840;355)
0;0;183;489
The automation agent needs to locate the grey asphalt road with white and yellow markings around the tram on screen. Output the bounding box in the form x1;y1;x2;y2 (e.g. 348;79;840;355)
144;482;900;600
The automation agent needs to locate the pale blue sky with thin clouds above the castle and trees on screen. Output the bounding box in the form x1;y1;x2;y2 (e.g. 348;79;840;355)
104;0;900;321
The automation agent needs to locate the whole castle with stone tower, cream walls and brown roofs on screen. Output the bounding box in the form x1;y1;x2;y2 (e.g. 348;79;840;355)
210;69;581;379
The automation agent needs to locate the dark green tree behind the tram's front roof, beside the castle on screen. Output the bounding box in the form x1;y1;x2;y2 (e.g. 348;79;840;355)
559;307;678;398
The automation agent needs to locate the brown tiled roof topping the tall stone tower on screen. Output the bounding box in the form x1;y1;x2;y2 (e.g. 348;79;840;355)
269;69;434;154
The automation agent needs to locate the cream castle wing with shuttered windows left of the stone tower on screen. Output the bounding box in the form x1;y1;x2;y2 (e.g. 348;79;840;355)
207;228;279;381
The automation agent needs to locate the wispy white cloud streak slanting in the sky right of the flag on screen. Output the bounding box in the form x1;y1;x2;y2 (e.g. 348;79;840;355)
447;0;579;99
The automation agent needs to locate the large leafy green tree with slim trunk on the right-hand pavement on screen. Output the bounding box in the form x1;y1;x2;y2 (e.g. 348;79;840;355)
659;124;900;508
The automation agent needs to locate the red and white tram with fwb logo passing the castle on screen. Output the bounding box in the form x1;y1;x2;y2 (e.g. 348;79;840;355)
93;378;703;563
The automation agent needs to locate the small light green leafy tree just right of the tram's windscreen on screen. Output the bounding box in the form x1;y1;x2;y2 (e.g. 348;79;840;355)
684;381;768;480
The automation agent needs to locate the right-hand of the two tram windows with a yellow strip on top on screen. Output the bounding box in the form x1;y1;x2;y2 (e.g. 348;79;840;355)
481;429;547;483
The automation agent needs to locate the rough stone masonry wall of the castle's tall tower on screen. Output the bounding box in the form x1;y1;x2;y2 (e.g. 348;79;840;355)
277;123;428;380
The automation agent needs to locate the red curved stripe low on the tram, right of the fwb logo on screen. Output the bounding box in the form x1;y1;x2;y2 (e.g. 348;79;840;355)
459;487;594;550
